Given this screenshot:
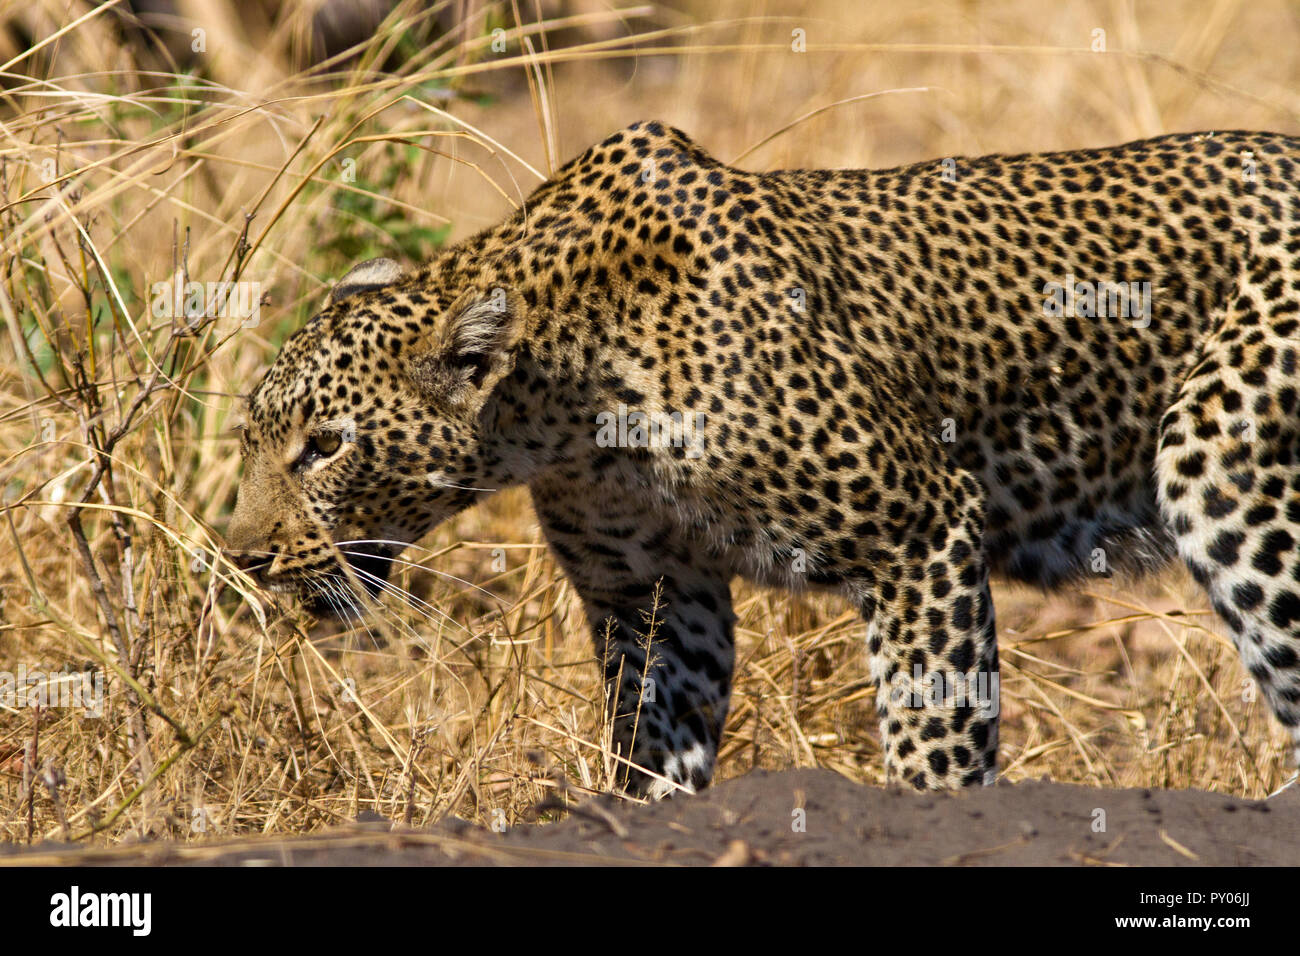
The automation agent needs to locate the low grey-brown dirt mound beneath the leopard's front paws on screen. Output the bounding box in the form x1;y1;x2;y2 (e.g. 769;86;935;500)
0;770;1300;866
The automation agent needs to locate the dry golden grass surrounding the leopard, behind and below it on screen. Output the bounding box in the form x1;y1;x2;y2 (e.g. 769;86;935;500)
0;0;1300;843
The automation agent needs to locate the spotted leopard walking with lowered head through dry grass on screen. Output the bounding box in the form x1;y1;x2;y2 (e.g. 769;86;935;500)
228;121;1300;797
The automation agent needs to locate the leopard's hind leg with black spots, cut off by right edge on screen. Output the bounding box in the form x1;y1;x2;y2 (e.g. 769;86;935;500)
1156;230;1300;775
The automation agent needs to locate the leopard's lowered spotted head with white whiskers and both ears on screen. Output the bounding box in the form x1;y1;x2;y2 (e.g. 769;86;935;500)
228;259;527;615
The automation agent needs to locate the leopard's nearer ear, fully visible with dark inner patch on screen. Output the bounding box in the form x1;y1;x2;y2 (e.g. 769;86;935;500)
410;287;524;405
